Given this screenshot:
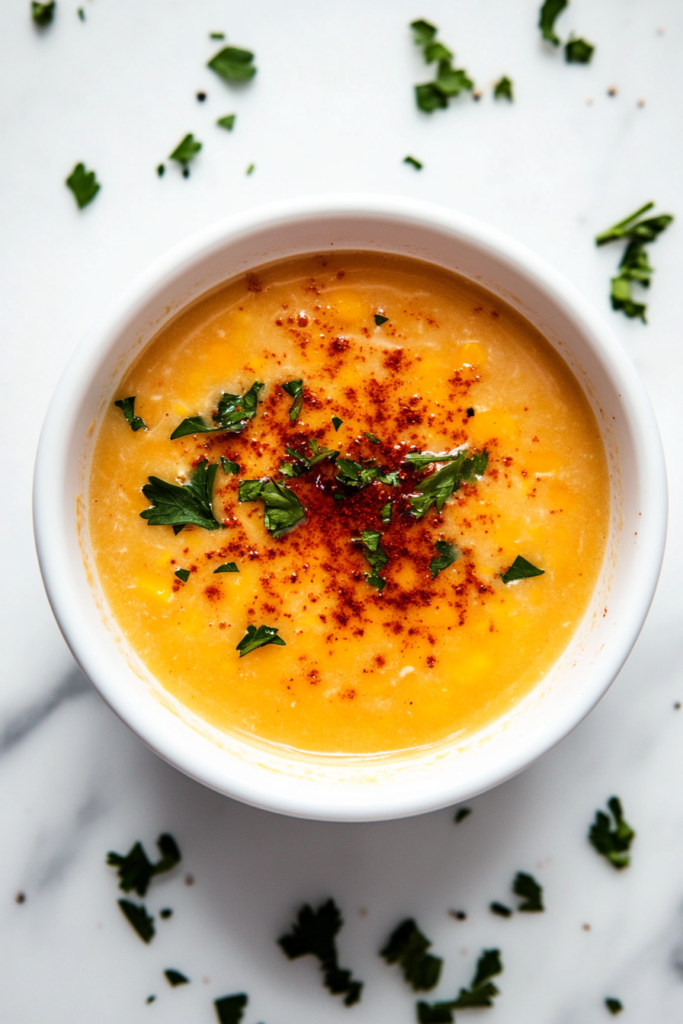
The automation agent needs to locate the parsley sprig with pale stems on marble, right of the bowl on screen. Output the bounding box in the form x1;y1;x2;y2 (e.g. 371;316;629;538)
595;203;674;324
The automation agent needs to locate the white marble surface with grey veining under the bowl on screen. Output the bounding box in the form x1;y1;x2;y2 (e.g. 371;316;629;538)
0;0;683;1024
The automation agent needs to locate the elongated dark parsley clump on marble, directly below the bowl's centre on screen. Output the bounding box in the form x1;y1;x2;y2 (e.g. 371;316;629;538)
278;899;362;1007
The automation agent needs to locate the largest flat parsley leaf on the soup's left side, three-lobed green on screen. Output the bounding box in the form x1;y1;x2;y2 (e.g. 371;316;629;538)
140;459;220;534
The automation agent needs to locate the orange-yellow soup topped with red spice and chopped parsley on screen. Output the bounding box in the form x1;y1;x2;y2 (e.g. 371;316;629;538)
89;253;609;753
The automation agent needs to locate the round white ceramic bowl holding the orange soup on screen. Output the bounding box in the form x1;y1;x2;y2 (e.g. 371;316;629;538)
34;195;667;821
